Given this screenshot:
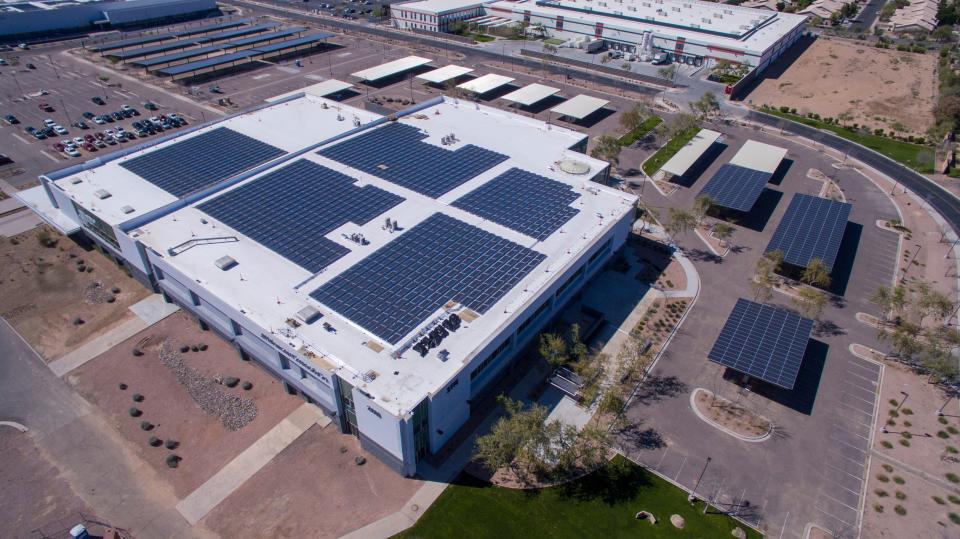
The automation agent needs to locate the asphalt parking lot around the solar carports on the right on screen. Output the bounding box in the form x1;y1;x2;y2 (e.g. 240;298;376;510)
621;125;898;538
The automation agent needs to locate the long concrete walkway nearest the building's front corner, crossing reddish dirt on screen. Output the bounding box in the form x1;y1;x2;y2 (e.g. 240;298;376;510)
177;402;330;526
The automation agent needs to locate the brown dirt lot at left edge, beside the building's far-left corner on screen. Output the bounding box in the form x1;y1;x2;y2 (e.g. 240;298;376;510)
0;226;150;361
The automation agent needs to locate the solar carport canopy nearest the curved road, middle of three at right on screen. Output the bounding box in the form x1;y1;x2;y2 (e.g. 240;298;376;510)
766;194;852;268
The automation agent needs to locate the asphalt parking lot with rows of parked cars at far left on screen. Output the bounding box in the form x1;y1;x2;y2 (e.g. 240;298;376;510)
0;46;218;190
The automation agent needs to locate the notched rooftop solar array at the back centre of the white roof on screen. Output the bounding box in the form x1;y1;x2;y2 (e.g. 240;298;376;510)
317;123;508;198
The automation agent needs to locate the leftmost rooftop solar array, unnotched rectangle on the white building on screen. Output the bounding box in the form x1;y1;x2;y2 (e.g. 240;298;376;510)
120;127;285;198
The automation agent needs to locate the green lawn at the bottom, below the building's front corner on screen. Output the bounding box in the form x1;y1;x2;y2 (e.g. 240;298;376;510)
395;456;761;539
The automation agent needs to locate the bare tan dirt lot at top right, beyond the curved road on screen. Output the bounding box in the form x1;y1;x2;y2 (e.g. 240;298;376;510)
747;39;937;134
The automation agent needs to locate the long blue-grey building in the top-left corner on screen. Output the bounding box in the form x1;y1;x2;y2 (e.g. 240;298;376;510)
0;0;218;40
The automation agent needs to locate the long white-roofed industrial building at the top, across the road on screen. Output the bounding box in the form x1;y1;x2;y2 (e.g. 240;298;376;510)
391;0;806;71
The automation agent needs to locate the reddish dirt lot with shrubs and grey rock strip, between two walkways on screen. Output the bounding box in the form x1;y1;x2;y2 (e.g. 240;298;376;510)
67;313;303;498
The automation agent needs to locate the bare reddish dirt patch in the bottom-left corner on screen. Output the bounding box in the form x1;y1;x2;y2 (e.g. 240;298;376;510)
0;427;90;537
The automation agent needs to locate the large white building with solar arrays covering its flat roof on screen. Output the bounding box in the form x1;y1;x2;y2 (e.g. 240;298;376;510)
19;92;636;475
